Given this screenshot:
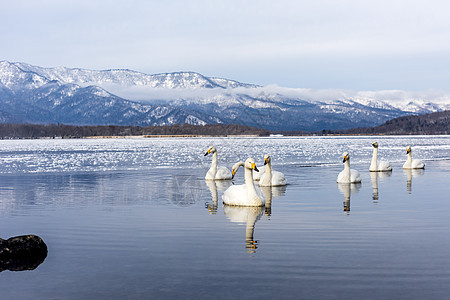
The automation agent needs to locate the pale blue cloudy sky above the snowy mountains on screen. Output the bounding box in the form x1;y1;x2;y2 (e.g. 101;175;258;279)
0;0;450;93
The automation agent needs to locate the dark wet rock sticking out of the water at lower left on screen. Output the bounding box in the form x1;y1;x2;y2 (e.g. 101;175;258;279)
0;235;47;272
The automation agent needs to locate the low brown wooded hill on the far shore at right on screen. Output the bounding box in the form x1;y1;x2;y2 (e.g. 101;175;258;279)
332;110;450;135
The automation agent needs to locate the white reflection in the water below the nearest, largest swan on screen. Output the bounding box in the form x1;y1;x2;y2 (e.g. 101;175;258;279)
223;205;264;253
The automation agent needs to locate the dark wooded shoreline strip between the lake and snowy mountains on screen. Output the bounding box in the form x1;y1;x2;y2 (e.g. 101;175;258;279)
0;110;450;139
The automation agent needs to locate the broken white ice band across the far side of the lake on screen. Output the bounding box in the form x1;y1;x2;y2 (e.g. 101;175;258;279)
0;136;450;173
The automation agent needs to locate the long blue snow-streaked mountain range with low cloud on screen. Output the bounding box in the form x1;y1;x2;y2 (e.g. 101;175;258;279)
0;61;450;130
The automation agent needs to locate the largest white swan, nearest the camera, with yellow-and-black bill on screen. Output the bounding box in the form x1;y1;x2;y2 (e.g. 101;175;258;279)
222;158;265;206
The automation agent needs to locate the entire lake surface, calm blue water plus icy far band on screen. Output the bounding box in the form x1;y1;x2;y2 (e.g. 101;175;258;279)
0;136;450;299
